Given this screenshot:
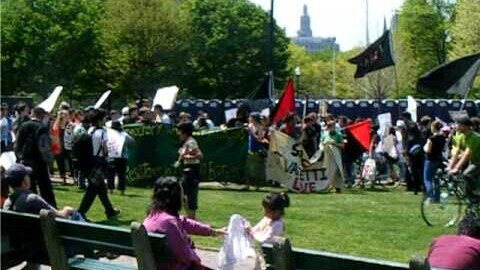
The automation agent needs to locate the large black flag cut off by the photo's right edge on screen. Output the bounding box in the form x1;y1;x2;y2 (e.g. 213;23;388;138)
417;53;480;95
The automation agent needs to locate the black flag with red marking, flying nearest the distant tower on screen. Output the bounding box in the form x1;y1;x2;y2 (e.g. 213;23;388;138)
348;30;395;78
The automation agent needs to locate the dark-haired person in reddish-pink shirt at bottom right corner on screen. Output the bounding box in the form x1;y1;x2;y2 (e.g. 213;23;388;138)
427;215;480;270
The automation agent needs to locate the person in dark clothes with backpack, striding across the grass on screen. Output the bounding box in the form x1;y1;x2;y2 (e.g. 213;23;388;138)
78;109;120;219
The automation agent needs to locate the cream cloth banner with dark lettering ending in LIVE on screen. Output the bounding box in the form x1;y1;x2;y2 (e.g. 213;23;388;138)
266;130;344;192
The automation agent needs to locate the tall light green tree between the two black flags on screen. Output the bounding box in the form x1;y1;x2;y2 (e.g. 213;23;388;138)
395;0;452;97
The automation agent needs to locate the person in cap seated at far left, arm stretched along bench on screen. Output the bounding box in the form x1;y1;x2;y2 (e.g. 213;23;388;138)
3;163;75;218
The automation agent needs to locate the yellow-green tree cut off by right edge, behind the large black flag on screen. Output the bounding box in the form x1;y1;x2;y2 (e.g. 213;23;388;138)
450;0;480;98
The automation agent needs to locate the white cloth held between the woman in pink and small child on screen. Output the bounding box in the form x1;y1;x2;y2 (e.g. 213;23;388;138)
217;214;255;270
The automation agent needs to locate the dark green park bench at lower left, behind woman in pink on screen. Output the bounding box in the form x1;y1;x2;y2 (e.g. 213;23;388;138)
1;210;170;270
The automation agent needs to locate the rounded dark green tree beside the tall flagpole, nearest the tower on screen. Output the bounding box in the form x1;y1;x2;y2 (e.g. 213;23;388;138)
183;0;289;98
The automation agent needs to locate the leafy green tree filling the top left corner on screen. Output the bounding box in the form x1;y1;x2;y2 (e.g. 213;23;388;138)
0;0;102;96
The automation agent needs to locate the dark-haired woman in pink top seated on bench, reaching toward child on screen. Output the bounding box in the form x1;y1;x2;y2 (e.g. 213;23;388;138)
143;177;224;270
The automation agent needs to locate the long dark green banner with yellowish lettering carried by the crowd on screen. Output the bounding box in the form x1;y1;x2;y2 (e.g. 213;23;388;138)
124;124;248;185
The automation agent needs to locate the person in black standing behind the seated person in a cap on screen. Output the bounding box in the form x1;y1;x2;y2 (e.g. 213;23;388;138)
14;107;57;207
